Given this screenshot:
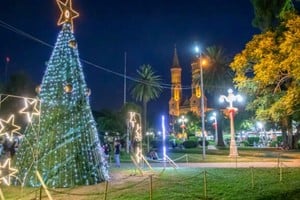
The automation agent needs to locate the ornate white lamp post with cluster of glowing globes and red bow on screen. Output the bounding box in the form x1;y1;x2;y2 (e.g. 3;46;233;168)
219;89;242;157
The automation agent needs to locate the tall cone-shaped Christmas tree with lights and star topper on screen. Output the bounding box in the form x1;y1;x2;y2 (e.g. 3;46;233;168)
16;0;108;187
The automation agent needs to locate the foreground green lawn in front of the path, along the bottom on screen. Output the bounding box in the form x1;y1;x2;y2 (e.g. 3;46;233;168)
2;168;300;200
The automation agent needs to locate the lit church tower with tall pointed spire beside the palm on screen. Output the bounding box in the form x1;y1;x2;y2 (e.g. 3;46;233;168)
169;47;182;116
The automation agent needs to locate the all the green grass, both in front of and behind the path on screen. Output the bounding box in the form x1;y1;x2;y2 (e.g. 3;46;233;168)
0;149;300;200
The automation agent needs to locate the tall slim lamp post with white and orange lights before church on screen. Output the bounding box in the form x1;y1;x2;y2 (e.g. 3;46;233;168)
195;47;205;160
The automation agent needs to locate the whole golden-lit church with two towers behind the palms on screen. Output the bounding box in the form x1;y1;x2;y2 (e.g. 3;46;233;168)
169;47;207;118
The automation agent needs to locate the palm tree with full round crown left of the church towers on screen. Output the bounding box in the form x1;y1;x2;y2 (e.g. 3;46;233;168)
131;65;162;134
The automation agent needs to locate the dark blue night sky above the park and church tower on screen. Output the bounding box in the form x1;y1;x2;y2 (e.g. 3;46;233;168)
0;0;259;119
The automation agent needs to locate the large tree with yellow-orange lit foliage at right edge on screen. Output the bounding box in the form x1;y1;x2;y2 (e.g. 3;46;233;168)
231;14;300;147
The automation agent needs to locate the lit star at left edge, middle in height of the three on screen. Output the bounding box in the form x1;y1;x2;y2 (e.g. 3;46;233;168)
0;115;21;140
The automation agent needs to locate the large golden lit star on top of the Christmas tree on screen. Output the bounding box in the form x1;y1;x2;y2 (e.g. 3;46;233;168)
56;0;79;32
